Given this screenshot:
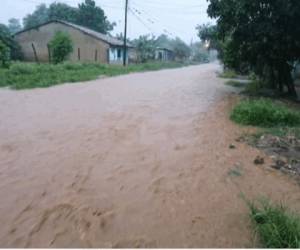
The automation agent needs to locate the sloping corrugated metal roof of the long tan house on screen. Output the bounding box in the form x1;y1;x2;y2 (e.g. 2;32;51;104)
15;20;132;47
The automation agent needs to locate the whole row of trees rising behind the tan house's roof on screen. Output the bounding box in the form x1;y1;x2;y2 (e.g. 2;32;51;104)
23;0;115;34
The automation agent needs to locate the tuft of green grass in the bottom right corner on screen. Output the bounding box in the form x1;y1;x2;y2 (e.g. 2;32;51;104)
249;201;300;248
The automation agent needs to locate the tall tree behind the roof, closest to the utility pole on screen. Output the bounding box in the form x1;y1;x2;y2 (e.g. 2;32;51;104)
77;0;115;34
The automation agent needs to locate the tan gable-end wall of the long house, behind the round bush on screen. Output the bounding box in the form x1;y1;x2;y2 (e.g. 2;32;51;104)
15;22;109;63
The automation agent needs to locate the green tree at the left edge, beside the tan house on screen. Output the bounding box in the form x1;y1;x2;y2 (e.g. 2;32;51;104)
0;24;23;60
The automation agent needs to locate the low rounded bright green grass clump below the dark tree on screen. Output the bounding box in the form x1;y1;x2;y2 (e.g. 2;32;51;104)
231;98;300;127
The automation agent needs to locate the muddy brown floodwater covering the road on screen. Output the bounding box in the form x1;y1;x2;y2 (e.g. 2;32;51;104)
0;64;300;247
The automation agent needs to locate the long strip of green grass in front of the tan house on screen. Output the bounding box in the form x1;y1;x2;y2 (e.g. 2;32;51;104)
0;62;185;89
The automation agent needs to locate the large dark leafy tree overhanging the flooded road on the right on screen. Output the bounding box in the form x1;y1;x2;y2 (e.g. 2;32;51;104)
208;0;300;97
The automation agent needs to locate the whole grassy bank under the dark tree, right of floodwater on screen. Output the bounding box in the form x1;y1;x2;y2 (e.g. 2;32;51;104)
219;71;300;138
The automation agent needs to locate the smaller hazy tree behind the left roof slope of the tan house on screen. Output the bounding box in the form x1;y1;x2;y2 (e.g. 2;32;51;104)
23;4;49;29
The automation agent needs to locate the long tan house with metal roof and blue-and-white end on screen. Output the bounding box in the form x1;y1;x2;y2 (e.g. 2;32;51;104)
14;20;134;64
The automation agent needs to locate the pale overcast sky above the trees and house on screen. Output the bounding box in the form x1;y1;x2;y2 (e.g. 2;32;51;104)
0;0;213;43
